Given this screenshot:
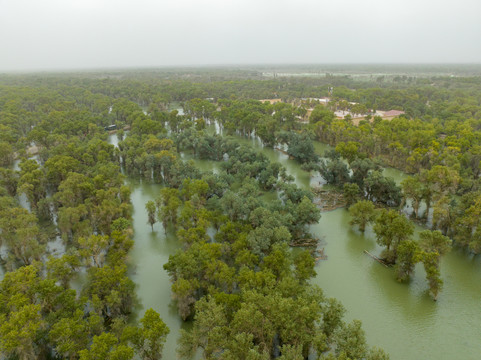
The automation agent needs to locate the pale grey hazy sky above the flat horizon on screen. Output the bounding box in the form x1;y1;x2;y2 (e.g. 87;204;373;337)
0;0;481;71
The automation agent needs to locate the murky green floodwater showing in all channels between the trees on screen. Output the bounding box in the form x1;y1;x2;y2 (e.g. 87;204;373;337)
118;129;481;360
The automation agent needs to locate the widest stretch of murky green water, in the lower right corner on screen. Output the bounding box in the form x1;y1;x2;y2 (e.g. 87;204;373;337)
312;214;481;360
